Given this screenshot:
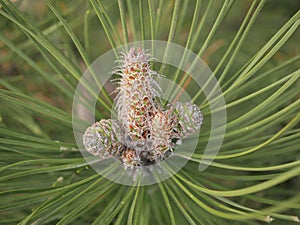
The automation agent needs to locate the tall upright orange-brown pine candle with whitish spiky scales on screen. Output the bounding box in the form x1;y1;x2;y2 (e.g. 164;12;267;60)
116;48;159;148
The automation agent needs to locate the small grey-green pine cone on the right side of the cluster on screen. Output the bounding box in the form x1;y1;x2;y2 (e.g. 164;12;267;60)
174;102;203;138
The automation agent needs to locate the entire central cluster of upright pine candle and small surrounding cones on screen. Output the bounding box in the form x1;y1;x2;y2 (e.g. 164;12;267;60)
83;48;203;167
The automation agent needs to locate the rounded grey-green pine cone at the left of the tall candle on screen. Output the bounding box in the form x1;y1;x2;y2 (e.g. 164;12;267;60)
83;120;124;159
